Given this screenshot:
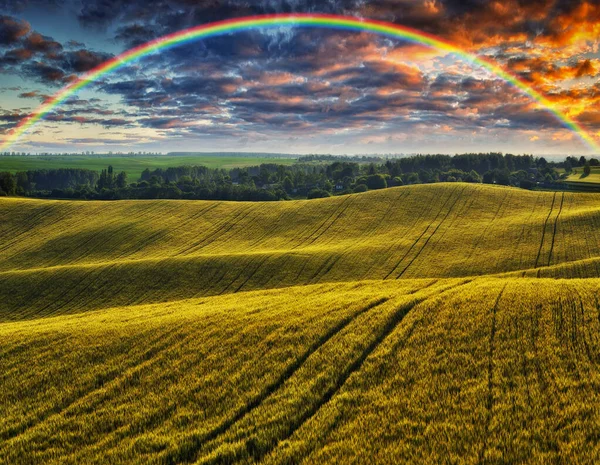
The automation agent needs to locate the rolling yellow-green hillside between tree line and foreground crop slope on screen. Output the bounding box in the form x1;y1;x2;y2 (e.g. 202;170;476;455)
0;184;600;320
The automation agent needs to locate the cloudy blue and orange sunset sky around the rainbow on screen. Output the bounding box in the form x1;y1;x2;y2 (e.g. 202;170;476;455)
0;0;600;155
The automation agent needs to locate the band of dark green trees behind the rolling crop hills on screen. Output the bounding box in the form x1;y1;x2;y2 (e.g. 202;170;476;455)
0;153;600;201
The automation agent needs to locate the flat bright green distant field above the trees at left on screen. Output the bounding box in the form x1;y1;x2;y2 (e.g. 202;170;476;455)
0;155;295;181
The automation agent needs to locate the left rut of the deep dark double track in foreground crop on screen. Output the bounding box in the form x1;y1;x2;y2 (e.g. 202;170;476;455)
165;297;389;465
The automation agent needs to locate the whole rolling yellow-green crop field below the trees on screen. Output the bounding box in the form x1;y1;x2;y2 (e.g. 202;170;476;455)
0;183;600;464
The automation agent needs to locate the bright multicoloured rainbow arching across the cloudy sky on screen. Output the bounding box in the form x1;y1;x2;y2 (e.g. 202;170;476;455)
0;14;600;153
